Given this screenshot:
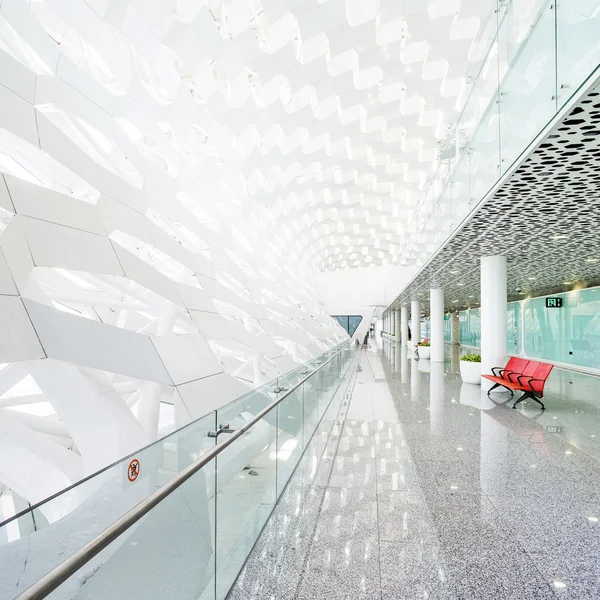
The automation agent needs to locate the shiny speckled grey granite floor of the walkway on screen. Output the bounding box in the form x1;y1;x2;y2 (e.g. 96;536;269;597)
229;344;600;600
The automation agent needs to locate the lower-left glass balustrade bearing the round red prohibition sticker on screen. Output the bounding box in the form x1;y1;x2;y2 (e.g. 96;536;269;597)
0;342;357;600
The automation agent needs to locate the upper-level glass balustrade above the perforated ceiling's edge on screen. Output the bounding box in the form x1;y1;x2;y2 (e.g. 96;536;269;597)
405;0;600;266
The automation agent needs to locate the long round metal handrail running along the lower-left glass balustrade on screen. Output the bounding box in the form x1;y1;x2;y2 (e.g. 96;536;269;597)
15;343;351;600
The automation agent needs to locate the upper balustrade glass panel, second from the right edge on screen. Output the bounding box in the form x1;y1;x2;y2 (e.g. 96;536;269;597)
499;1;556;173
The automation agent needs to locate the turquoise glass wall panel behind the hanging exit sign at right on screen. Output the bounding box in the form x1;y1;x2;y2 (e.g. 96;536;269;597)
524;288;600;369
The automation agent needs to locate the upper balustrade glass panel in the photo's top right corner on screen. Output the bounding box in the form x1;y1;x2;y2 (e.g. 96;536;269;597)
556;0;600;106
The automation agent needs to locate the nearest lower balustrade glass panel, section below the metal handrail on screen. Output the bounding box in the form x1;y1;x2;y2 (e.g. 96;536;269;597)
28;461;215;600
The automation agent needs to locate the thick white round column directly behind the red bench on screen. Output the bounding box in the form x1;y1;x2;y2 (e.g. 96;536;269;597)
481;256;507;389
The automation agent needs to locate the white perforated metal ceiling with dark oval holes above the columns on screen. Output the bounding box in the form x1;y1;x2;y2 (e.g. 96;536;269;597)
391;84;600;311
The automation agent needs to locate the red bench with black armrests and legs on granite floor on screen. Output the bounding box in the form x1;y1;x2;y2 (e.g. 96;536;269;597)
482;357;553;410
